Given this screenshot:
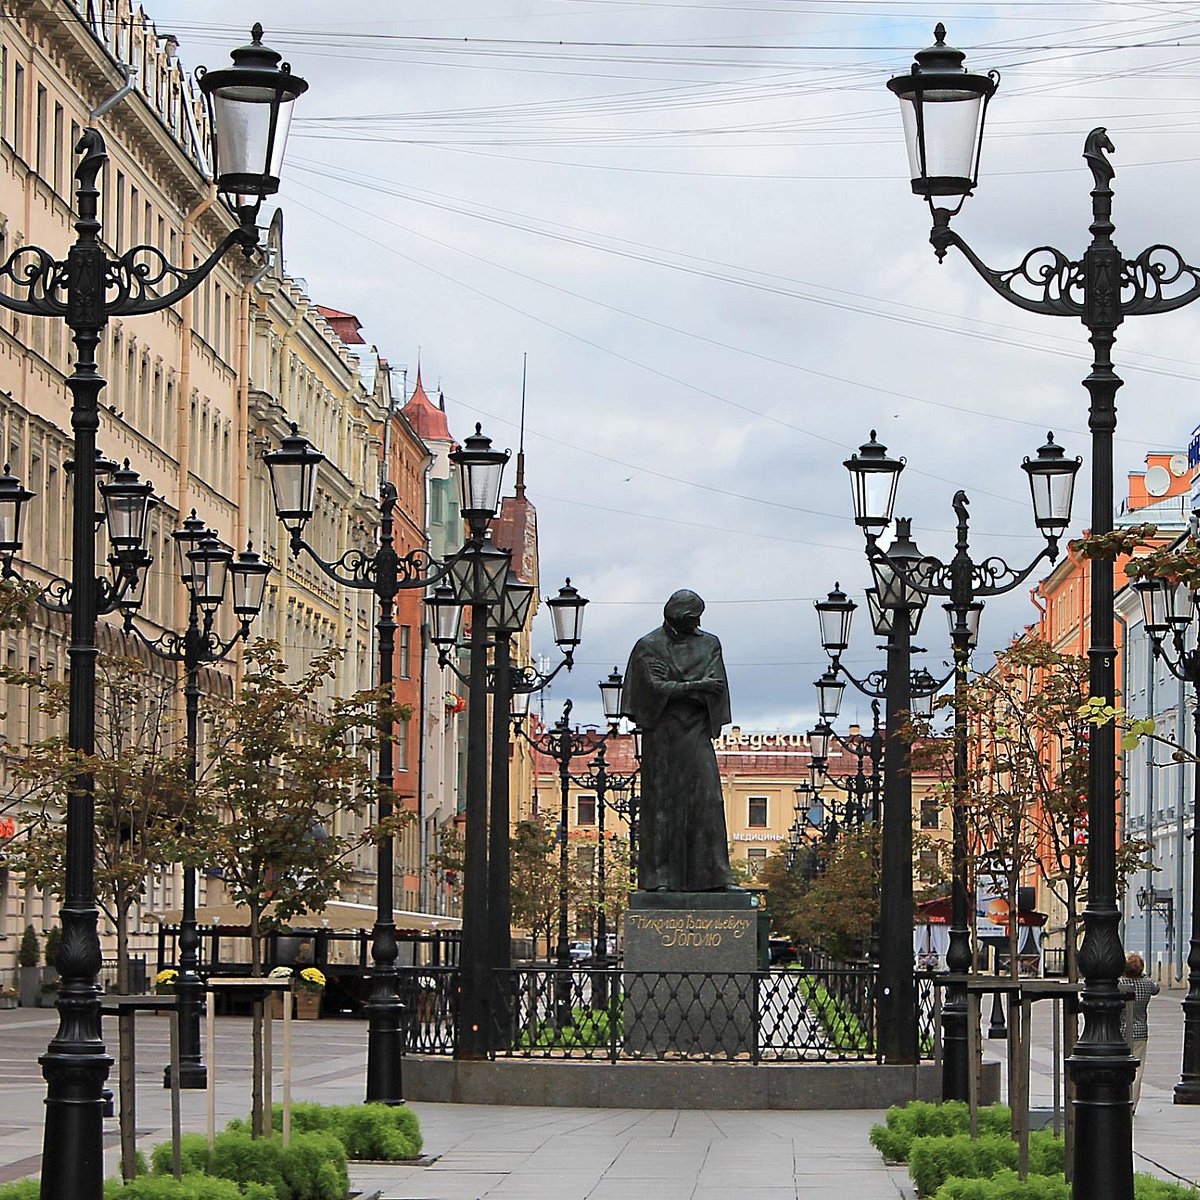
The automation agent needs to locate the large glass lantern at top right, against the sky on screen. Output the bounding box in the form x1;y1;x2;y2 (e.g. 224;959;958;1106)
888;24;1000;201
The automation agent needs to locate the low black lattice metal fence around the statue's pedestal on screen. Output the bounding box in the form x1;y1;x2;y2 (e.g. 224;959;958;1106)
401;967;937;1062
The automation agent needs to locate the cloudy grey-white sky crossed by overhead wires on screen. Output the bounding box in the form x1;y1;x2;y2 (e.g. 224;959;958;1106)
146;0;1200;730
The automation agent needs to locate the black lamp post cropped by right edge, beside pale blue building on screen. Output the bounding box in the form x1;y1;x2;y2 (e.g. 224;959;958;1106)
1134;575;1200;1104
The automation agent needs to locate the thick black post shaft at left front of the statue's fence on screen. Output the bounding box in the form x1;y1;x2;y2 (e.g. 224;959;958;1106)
455;576;490;1058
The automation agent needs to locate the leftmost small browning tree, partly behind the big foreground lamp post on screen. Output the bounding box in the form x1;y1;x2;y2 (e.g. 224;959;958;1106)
6;654;193;992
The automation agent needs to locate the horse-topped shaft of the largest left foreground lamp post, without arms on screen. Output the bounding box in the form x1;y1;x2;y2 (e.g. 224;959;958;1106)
38;130;113;1200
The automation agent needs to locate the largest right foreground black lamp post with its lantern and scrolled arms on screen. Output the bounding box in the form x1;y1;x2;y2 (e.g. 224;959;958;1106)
888;24;1200;1200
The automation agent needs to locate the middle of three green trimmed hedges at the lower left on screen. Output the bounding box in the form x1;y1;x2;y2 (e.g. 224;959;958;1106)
151;1129;350;1200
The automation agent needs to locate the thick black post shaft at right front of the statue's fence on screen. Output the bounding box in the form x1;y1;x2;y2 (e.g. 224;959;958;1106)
878;608;917;1064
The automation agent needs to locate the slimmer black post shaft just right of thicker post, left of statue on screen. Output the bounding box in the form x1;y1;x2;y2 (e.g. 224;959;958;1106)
487;634;512;1046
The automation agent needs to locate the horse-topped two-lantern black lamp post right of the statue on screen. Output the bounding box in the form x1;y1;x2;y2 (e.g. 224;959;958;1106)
847;431;1081;1100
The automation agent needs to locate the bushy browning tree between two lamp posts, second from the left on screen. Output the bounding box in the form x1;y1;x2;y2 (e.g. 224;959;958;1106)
188;641;409;974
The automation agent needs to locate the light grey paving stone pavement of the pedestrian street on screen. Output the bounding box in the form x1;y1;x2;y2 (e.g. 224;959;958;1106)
0;992;1200;1200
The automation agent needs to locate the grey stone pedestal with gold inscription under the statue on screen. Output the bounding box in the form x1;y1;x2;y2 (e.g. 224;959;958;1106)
624;892;758;1058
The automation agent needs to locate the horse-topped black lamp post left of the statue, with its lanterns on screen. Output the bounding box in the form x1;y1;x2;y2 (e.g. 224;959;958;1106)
263;425;508;1104
